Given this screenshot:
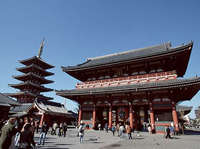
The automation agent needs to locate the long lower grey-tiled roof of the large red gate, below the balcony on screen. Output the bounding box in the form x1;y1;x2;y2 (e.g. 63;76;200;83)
56;77;200;99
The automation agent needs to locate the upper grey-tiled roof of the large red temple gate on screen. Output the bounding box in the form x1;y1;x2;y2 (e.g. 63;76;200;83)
62;42;193;73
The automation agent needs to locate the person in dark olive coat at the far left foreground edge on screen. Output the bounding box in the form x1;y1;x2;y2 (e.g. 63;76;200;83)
0;117;17;149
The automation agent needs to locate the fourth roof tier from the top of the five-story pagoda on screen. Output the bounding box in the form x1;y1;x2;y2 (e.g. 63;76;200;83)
9;81;53;92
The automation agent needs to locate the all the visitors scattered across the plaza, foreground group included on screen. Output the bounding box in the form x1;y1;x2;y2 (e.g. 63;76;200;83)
0;117;184;149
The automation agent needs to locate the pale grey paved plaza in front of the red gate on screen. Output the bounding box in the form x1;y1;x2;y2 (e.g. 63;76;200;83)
35;129;200;149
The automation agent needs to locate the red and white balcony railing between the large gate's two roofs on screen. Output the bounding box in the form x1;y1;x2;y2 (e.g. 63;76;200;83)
76;71;177;89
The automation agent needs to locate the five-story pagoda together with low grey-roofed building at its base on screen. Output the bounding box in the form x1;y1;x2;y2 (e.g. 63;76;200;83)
7;41;75;125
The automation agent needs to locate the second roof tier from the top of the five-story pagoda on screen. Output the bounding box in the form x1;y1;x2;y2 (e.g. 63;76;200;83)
17;64;54;76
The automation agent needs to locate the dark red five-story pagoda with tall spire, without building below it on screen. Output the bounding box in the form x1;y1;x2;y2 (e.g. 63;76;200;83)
8;41;54;103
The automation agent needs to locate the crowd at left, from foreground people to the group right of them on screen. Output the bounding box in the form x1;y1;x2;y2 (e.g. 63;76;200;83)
0;117;67;149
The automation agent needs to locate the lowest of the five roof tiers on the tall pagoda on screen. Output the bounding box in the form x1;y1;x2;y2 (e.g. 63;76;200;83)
7;91;53;100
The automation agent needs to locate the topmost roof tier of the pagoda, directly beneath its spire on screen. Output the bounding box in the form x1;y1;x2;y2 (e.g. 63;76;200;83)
19;56;54;69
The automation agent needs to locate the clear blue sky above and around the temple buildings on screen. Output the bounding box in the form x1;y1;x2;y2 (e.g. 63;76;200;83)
0;0;200;117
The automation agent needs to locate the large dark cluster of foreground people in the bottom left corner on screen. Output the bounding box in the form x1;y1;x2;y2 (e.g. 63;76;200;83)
0;117;36;149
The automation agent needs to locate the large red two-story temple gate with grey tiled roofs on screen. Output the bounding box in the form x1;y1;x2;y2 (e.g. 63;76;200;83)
56;42;200;133
